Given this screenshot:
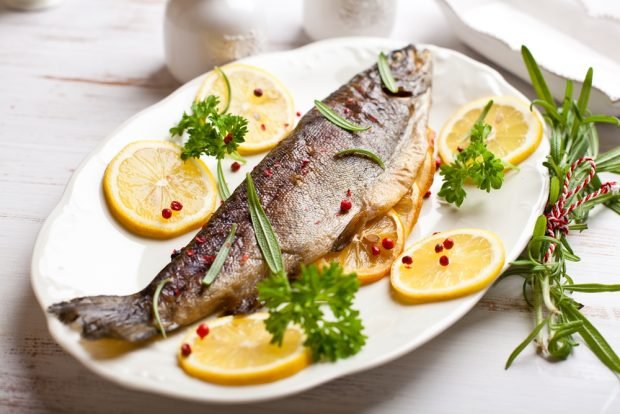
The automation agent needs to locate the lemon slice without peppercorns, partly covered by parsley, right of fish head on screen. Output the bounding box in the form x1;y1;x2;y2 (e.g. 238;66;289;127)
438;96;543;164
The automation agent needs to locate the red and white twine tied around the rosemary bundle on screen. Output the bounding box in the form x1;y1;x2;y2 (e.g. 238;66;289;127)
544;157;616;262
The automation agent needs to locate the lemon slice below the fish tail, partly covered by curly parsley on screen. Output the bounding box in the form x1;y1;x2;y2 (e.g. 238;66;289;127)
178;313;311;385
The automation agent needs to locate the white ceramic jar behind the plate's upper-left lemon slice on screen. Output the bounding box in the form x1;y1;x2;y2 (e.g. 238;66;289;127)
164;0;265;82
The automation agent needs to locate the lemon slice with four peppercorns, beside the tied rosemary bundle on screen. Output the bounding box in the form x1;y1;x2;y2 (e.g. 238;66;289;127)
391;229;505;302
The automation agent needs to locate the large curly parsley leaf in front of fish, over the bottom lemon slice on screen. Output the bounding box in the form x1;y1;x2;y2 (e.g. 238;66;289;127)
258;262;366;361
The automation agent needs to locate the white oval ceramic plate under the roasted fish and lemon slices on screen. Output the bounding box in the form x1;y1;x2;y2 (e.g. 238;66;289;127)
32;38;548;403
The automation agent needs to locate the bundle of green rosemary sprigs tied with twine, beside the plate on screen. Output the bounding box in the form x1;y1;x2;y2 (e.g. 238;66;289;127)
502;46;620;373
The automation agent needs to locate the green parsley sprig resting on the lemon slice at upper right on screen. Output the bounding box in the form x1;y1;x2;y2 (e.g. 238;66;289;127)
438;101;505;206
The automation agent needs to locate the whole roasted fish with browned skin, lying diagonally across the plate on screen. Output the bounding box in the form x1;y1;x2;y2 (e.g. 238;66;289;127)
49;46;432;342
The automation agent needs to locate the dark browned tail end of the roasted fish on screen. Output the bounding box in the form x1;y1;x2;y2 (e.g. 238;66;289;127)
47;294;157;342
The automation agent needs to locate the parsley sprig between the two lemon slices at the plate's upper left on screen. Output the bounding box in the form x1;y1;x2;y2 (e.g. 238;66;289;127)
170;95;248;199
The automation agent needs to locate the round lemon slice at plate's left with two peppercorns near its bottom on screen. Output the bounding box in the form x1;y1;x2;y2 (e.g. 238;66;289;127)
103;141;217;238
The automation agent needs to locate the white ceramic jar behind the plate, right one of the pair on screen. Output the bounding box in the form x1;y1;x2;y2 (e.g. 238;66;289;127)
304;0;397;40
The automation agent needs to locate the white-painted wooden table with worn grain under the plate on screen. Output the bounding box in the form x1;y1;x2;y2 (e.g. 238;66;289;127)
0;0;620;414
